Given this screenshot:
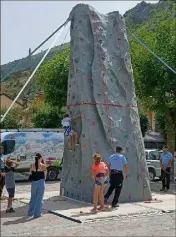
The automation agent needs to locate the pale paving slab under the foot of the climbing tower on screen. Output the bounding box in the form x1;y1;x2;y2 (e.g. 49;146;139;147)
47;194;176;223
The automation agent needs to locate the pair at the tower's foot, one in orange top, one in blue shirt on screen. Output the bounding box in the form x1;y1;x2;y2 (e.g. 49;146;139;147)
92;147;129;212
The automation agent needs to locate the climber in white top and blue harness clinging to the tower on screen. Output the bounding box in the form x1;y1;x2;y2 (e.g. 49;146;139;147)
62;113;81;149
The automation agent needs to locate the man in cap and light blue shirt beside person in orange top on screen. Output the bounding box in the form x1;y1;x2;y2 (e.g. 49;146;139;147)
104;147;129;208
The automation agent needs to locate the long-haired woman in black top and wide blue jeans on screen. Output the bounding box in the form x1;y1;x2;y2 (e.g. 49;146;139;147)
28;153;46;218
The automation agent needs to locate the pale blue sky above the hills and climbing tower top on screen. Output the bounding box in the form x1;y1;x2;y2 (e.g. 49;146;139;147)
1;1;158;64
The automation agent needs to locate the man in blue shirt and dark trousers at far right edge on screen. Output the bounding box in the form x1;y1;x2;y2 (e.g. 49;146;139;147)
160;146;174;191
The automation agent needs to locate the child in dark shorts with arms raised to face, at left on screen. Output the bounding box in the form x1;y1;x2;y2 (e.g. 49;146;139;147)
5;160;19;213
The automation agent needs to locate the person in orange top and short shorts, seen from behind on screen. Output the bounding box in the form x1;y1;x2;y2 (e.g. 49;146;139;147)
91;153;109;212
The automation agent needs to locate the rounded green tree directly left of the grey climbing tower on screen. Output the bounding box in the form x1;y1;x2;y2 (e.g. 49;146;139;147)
37;47;70;110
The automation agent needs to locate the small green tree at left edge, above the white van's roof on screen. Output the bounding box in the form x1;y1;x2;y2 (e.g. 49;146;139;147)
0;109;21;129
